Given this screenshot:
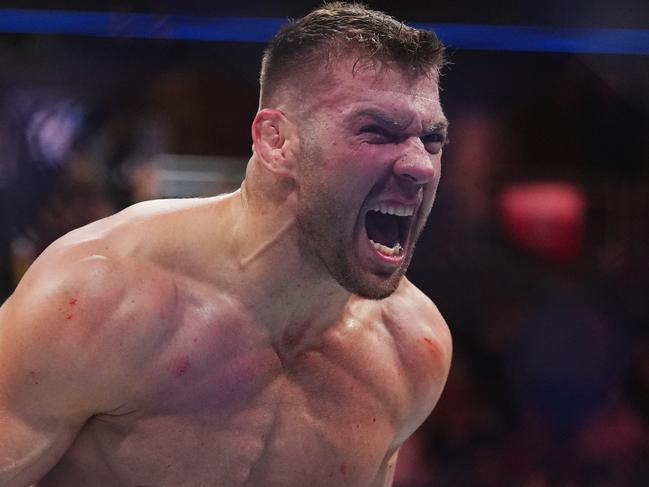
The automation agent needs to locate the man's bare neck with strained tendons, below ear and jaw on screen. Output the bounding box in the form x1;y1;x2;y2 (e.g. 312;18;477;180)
230;183;350;352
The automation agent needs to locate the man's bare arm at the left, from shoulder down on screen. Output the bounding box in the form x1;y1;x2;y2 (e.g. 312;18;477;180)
0;250;128;487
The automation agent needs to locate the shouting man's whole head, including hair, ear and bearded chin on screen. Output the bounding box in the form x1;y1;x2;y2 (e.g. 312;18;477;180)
247;3;448;299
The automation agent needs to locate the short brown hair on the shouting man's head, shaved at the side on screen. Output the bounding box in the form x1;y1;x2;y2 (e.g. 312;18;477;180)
260;2;445;106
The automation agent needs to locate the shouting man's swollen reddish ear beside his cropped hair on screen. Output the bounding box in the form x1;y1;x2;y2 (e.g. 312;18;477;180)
252;108;296;178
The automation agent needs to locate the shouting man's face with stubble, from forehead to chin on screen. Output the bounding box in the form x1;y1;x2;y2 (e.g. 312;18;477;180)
297;59;448;299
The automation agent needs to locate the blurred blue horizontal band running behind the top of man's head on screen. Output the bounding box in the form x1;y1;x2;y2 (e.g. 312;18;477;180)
0;9;649;55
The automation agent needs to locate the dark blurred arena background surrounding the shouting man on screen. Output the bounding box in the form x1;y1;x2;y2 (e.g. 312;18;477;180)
0;0;649;487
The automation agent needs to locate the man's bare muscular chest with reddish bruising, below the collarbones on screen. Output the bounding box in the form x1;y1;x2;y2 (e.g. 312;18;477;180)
50;312;397;487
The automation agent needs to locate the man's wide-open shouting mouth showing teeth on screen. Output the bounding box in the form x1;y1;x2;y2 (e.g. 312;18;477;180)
365;203;415;258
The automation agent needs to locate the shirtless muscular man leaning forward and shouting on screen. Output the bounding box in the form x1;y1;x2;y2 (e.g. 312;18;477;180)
0;3;451;487
